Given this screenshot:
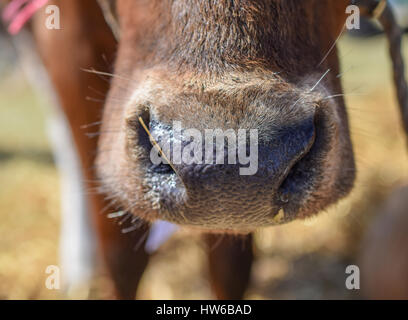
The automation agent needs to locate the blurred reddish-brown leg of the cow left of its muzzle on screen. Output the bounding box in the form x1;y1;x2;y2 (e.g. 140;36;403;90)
33;0;147;299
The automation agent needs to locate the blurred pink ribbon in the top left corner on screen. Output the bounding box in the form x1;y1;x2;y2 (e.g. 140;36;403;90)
2;0;49;35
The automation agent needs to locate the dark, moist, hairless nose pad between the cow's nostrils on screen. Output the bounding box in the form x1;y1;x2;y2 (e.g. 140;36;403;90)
151;115;315;205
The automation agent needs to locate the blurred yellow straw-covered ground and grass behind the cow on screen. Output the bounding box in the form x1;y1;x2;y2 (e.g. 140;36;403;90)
0;1;408;299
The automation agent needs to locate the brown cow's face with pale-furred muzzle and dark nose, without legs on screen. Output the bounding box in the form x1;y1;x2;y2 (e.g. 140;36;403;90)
97;0;354;232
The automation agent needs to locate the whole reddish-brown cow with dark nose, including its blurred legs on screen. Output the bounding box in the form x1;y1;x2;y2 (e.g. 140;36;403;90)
3;0;406;299
